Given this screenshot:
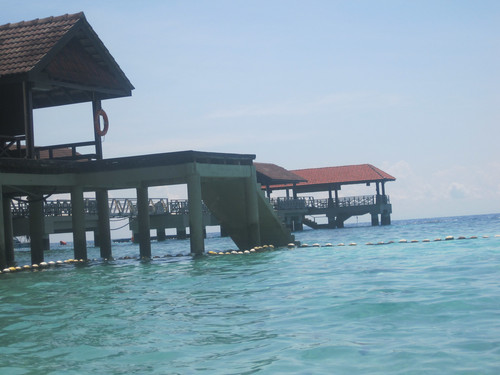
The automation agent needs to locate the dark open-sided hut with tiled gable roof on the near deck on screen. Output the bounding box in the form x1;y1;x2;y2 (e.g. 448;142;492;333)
0;13;134;159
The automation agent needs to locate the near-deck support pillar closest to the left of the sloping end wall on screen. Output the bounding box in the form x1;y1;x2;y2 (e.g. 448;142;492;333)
188;172;205;255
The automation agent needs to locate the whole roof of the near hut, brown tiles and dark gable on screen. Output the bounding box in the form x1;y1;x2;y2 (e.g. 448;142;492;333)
0;13;134;108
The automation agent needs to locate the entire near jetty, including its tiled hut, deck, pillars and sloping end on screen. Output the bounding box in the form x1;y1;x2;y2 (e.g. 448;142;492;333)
0;13;293;267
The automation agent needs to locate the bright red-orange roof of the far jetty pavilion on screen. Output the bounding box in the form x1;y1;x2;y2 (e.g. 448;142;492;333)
271;164;396;192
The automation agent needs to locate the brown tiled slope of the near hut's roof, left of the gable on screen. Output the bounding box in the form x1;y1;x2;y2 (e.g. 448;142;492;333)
0;13;85;77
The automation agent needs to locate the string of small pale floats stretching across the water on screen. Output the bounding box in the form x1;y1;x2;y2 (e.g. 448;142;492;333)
0;234;500;274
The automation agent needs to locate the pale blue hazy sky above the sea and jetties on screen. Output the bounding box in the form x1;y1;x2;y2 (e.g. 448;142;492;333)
0;0;500;220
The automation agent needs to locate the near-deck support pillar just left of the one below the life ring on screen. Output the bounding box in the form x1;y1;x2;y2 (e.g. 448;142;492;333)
71;186;87;260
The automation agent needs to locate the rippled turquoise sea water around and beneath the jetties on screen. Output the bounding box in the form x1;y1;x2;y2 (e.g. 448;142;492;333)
0;214;500;375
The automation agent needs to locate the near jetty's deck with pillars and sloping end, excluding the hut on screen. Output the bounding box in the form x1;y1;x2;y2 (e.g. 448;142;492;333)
0;151;293;263
